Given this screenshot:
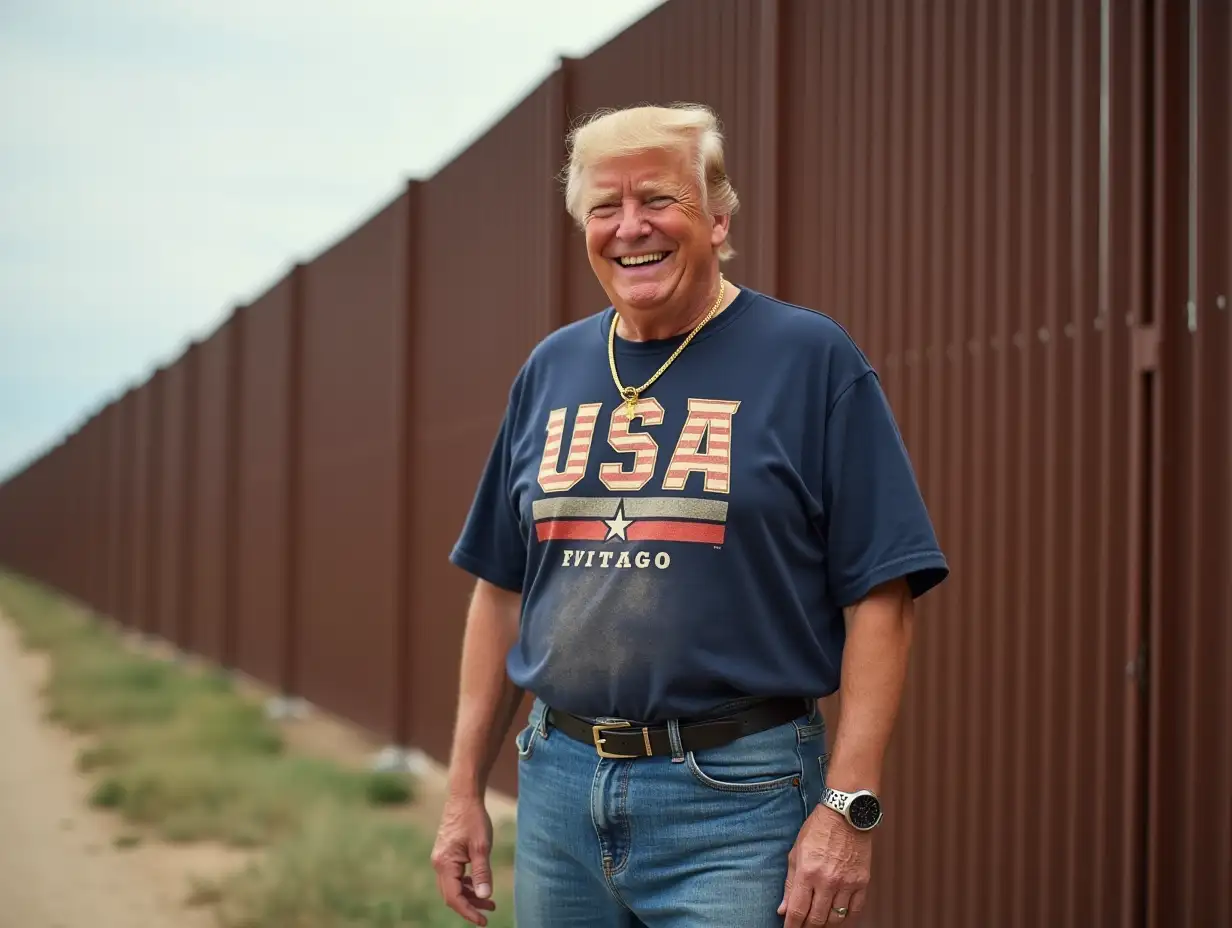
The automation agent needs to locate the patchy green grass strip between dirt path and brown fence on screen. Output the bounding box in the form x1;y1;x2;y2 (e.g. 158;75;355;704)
0;572;514;928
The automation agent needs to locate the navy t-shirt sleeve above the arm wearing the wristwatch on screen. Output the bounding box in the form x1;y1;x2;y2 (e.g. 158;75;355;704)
822;371;949;606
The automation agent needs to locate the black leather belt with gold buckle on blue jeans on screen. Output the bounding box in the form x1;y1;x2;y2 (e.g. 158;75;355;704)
547;696;813;759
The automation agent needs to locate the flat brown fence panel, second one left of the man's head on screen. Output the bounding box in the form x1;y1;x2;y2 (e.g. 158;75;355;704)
297;196;406;735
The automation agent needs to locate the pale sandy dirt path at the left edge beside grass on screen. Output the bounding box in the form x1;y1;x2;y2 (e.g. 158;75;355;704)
0;615;235;928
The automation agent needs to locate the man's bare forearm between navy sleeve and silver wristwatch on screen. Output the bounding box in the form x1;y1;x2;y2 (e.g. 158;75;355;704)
827;582;914;791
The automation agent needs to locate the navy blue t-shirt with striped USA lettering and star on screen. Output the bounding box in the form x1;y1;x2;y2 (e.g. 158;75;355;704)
450;288;949;721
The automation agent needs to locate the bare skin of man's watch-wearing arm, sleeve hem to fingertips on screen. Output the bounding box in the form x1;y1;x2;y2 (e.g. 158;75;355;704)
779;579;915;928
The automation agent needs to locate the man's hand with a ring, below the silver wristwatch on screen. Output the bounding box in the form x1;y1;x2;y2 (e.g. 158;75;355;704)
779;806;872;928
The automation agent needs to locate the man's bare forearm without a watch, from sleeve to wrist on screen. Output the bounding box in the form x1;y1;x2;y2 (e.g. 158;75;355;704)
448;580;522;797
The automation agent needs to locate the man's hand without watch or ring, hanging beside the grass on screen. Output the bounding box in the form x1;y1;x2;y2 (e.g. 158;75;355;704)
432;795;496;926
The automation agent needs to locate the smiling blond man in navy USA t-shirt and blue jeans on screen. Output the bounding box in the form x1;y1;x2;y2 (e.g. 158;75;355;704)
432;106;947;928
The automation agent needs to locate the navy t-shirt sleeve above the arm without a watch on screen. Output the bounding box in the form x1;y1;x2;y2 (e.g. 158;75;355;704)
450;384;526;593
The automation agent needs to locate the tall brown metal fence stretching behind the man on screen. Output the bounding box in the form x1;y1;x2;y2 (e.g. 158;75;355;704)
0;0;1232;928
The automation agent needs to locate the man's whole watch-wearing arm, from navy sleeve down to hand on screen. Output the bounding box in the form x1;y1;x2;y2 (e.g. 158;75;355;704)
779;364;949;928
